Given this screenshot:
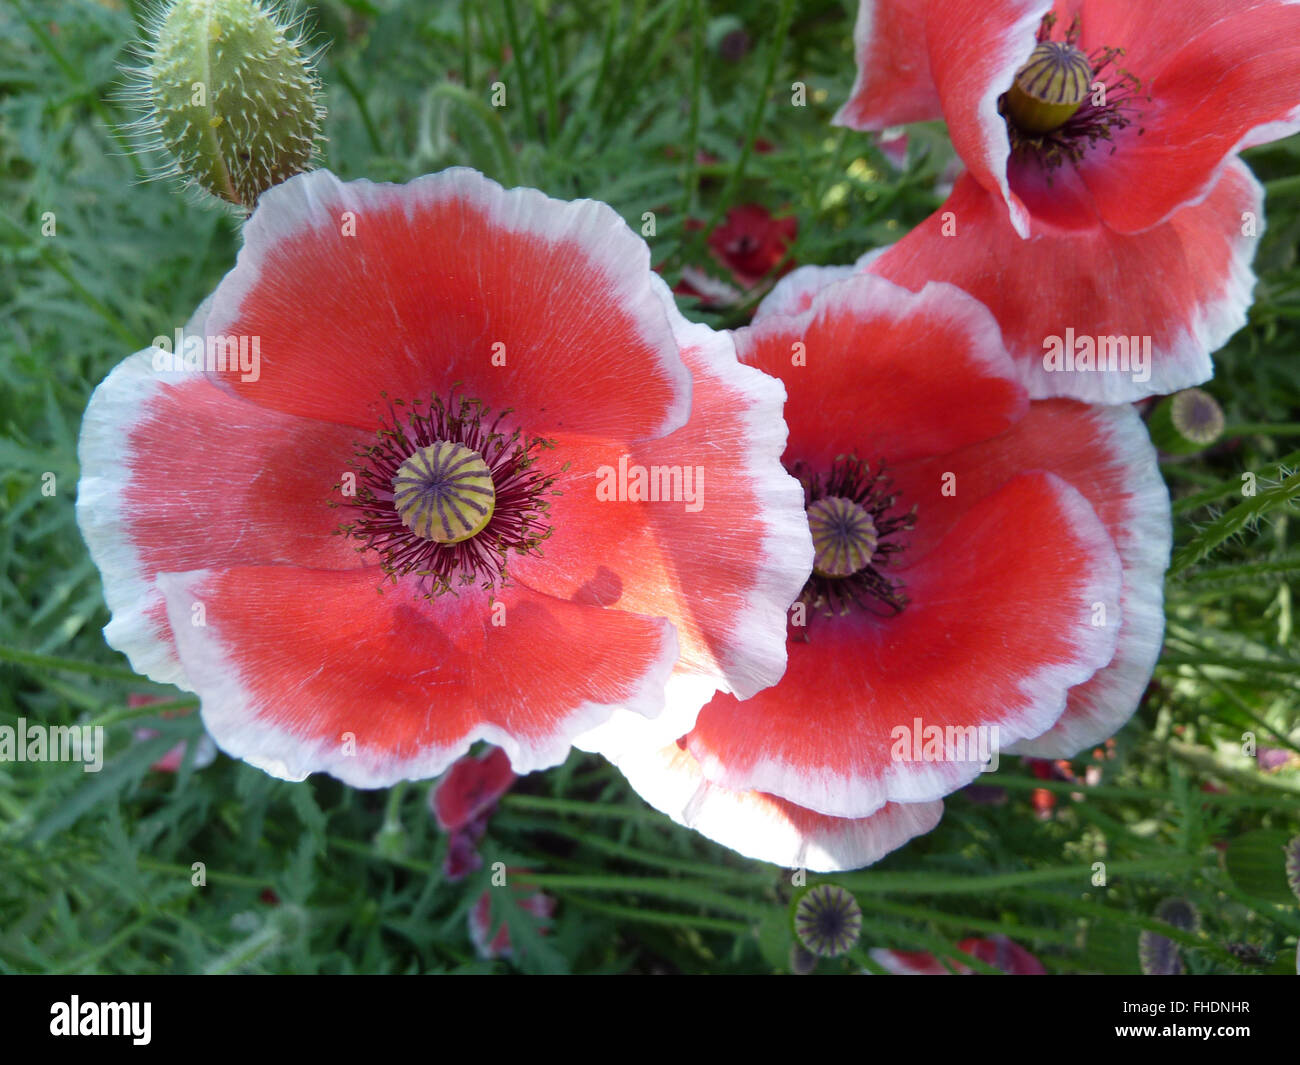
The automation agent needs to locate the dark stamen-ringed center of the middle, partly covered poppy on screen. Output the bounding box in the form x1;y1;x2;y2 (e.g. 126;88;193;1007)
790;455;915;616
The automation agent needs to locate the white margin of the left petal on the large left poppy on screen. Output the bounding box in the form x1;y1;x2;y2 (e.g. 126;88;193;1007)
77;347;201;692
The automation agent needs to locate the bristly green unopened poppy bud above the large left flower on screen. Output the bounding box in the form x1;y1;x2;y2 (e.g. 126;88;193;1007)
137;0;324;208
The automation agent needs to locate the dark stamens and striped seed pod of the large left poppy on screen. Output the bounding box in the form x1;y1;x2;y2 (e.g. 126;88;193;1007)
332;397;555;597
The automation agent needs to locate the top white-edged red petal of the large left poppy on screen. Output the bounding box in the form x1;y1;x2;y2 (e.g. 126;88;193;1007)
202;168;690;440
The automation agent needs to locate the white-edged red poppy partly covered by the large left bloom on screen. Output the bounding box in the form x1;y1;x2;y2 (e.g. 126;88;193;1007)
584;274;1170;871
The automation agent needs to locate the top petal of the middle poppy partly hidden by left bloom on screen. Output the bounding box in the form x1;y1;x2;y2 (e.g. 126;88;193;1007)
736;274;1026;468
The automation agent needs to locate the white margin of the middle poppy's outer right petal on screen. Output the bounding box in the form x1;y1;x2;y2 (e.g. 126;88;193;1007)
1008;406;1173;758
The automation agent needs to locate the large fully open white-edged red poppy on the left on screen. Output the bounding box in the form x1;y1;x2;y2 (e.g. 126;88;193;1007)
77;169;811;787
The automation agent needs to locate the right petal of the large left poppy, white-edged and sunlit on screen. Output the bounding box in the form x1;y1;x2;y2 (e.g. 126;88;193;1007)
510;308;813;707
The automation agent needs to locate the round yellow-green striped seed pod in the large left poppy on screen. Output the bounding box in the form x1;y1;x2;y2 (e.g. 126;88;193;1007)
393;440;497;544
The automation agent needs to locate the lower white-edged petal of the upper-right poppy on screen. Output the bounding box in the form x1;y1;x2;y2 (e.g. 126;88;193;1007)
870;161;1264;403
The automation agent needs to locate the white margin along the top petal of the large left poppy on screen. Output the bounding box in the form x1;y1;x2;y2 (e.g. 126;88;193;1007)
205;166;692;438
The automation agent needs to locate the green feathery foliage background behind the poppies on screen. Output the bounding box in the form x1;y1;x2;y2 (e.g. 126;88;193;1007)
0;0;1300;973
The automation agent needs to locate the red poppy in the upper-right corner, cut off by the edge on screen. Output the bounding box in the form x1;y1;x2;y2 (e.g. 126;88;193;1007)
836;0;1300;402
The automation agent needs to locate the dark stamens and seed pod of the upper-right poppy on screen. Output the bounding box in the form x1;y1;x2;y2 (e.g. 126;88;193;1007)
998;14;1151;169
